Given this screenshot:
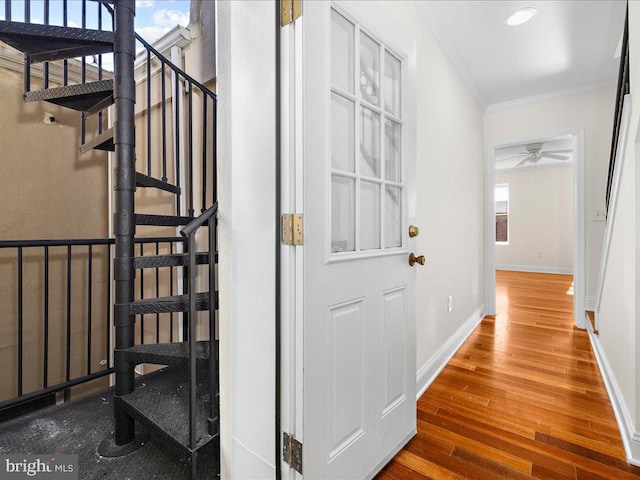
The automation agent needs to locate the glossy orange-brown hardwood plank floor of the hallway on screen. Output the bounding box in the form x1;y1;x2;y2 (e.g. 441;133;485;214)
376;271;640;480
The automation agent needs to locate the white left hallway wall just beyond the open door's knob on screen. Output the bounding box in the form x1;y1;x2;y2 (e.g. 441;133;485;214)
372;2;484;391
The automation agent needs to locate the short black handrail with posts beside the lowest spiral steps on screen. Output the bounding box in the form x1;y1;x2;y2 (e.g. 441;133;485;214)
180;202;219;458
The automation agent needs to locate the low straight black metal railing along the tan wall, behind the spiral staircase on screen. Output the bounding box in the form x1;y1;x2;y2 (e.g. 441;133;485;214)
0;237;185;409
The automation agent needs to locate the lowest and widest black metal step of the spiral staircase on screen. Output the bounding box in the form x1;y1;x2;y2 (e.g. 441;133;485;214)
115;367;218;454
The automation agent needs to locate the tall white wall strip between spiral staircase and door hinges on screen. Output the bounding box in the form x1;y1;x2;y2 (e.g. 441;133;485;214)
216;1;277;479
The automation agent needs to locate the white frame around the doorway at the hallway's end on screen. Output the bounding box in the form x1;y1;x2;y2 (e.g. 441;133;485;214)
485;128;586;329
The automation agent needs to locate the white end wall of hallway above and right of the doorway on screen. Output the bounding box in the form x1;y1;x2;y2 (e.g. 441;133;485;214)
484;90;615;297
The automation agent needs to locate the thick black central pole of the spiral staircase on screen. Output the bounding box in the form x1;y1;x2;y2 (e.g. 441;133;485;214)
114;0;136;445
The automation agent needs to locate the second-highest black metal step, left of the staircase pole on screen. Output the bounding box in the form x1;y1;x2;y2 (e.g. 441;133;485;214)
24;80;113;112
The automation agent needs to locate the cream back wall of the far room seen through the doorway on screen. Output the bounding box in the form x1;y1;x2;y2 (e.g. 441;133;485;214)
496;165;573;273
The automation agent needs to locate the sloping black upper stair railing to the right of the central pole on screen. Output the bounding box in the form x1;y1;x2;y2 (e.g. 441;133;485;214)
136;34;217;217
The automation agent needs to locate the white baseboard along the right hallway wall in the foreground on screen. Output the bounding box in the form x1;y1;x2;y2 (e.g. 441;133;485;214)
587;322;640;466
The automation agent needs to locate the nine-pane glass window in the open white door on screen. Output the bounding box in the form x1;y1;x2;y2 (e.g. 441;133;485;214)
327;9;405;254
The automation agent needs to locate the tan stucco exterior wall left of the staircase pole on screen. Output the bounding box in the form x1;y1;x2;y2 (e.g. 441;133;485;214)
0;50;109;401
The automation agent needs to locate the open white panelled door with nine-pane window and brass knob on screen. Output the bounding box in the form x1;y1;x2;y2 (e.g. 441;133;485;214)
302;1;424;480
